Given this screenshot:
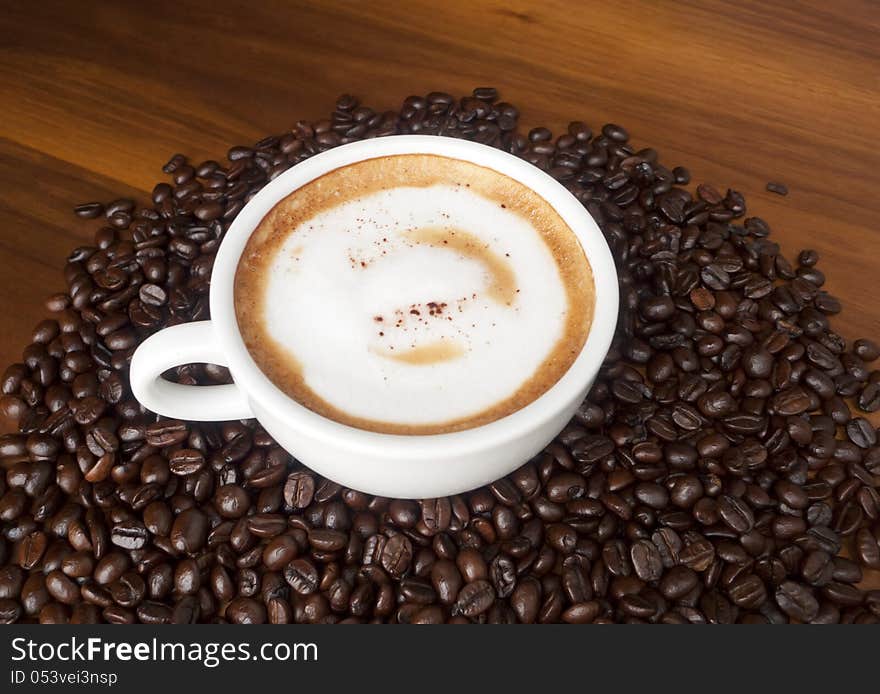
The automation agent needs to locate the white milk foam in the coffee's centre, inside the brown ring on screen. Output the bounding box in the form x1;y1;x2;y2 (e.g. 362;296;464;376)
263;183;569;426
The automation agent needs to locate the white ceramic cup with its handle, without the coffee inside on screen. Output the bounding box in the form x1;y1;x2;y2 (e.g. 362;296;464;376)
131;135;618;498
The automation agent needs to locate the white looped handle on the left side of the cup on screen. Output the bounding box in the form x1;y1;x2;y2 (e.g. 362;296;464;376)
129;321;254;422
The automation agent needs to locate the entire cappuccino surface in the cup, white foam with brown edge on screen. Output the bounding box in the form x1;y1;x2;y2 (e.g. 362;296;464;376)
235;154;594;434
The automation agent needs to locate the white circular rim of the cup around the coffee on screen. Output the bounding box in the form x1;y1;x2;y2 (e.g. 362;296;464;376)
209;135;619;459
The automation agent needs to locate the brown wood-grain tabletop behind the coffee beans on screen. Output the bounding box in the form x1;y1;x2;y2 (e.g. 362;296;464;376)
0;0;880;585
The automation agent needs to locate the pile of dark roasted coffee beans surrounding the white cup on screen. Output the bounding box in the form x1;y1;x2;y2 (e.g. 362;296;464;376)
0;88;880;624
